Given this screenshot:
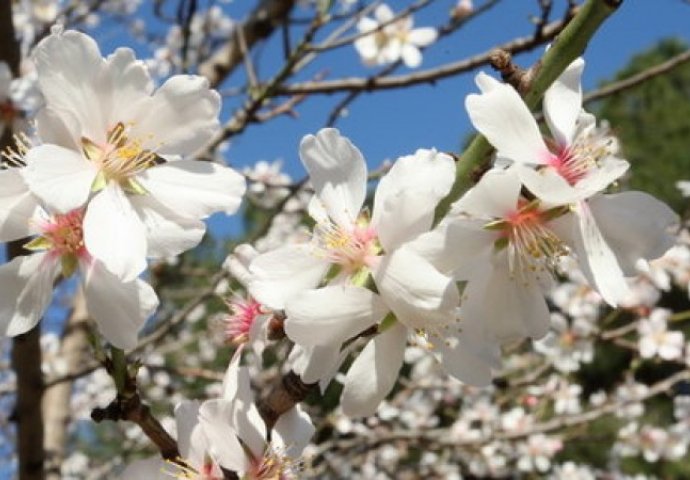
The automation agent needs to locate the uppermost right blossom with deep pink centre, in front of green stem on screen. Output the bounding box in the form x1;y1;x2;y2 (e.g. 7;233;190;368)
465;58;678;306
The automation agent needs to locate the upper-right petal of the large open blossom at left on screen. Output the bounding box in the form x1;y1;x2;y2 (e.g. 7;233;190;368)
129;75;220;156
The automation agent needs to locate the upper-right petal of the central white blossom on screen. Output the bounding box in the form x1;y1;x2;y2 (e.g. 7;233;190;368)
371;150;455;250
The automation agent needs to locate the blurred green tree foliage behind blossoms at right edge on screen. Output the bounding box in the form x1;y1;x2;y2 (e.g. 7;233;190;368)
598;39;690;211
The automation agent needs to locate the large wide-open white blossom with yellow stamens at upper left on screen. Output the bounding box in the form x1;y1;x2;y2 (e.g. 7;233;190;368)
25;28;245;280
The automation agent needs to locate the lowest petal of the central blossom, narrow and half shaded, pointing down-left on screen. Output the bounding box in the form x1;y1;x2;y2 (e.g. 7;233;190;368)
340;323;407;417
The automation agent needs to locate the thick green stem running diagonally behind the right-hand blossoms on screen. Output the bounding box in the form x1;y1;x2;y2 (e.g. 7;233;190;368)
434;0;623;223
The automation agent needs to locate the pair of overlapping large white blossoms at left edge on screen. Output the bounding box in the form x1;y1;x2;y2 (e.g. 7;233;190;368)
0;28;245;349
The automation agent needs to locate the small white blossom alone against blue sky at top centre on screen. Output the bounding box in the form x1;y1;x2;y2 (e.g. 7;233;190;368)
354;3;438;68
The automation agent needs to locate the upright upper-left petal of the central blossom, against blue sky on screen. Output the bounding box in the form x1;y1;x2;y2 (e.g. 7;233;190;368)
300;128;367;228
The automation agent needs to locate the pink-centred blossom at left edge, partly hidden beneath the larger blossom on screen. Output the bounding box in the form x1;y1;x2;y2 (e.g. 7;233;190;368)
0;206;158;349
